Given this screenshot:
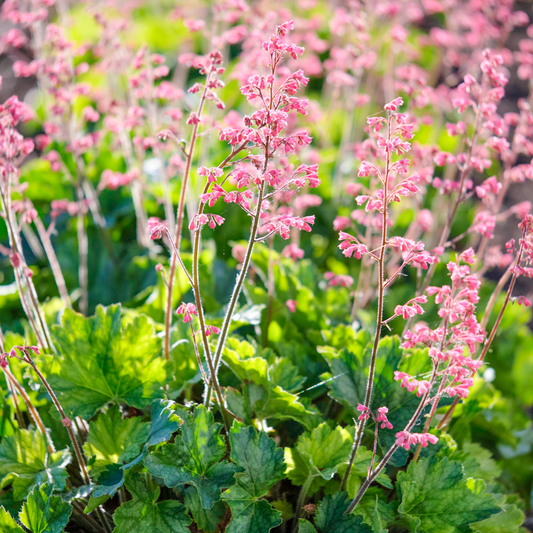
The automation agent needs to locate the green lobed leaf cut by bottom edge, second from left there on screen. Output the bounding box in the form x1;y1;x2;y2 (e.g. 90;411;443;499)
113;472;191;533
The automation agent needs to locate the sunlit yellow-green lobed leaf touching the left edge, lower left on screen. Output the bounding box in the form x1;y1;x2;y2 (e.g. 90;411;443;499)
0;429;71;500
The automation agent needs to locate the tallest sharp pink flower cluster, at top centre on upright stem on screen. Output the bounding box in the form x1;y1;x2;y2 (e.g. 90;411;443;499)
189;21;320;247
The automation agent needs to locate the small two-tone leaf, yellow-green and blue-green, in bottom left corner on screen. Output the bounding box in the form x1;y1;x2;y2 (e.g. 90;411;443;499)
20;483;72;533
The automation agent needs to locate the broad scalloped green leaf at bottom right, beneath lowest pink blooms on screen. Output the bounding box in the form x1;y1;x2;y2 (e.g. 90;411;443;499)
396;456;501;533
